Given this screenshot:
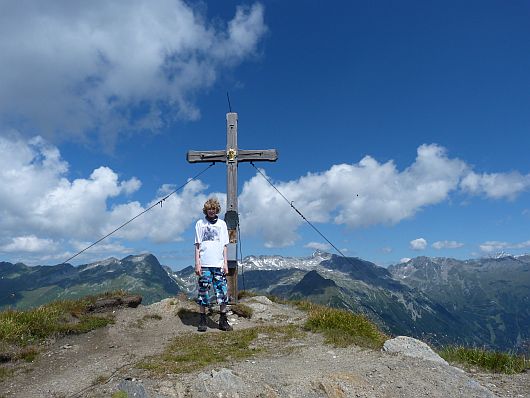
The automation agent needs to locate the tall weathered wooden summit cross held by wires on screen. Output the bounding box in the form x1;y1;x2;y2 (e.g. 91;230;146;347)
187;112;278;302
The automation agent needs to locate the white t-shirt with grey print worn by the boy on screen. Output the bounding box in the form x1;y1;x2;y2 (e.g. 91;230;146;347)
195;218;229;267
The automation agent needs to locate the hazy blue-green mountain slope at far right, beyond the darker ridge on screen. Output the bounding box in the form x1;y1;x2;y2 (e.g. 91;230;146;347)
389;256;530;350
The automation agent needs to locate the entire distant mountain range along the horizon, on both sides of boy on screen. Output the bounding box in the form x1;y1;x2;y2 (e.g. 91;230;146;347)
0;251;530;351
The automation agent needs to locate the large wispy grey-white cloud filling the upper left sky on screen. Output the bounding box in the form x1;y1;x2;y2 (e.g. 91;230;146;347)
0;0;267;145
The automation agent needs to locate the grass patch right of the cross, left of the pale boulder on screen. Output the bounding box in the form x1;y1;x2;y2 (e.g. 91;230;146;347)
297;302;388;349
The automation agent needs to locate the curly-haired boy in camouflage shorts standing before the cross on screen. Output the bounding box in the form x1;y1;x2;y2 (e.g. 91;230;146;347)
195;198;232;332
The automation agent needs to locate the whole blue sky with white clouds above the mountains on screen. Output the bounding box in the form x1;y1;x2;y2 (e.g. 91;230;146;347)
0;0;530;269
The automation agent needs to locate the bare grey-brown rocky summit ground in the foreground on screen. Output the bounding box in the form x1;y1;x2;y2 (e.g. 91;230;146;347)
0;297;530;398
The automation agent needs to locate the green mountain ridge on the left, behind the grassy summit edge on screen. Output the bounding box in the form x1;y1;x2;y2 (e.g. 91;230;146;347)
0;254;180;309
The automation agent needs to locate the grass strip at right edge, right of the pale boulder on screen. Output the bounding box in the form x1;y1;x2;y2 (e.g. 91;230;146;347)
438;346;530;374
